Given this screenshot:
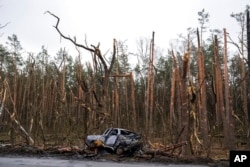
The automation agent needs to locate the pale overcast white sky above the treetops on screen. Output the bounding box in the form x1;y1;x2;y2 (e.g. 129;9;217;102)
0;0;250;59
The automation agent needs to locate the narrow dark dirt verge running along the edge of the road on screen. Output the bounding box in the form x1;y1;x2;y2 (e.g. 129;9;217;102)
0;144;229;166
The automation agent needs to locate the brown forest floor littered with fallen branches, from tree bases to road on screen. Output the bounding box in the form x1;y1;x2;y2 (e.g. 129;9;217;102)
0;134;250;166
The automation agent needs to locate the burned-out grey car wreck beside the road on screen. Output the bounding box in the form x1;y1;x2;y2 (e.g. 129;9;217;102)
85;128;142;156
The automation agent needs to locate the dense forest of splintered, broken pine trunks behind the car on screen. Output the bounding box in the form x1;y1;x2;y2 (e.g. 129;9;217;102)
0;8;250;156
